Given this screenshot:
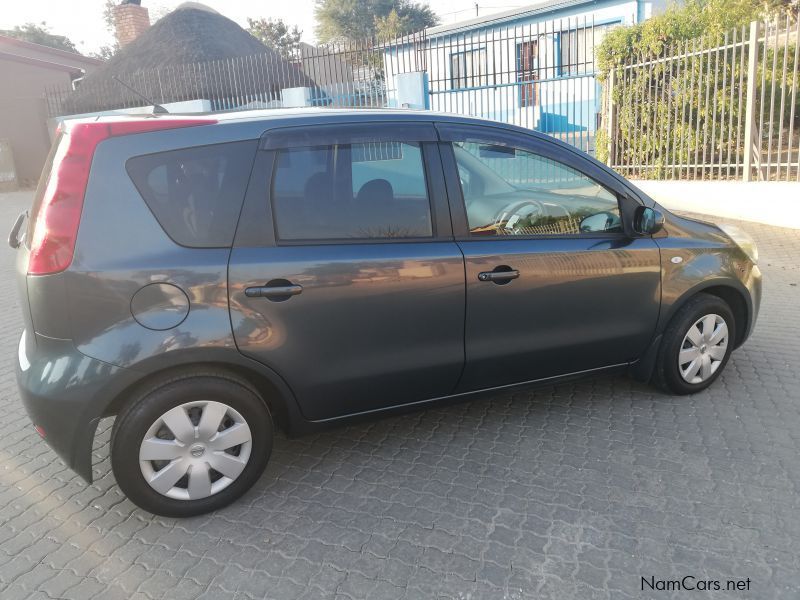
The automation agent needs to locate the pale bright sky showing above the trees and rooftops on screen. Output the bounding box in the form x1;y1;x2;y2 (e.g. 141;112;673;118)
0;0;537;53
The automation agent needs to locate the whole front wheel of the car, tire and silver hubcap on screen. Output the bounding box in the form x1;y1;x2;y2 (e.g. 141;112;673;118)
654;294;736;395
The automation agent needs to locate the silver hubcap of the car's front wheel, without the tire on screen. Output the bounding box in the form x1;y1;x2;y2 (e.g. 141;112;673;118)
678;315;728;383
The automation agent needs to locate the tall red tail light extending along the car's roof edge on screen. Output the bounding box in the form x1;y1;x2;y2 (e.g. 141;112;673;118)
28;118;217;275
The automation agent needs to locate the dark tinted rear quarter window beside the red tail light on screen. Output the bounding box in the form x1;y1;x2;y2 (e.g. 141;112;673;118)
126;140;258;248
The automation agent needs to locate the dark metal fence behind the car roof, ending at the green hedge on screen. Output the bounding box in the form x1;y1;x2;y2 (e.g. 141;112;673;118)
46;18;609;153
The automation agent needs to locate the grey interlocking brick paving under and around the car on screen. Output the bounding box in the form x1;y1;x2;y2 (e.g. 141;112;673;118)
0;189;800;600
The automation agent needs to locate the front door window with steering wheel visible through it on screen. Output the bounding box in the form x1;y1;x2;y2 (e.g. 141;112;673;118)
453;142;623;236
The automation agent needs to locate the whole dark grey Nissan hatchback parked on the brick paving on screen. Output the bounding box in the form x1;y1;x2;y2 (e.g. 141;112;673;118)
14;109;761;516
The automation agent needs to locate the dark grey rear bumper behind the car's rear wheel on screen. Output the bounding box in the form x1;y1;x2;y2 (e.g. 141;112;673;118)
16;331;136;483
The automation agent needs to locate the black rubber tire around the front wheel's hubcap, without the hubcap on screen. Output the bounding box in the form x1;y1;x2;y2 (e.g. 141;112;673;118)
653;293;736;395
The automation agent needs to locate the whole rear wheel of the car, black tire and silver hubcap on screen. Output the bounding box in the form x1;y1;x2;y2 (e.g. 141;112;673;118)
111;372;273;517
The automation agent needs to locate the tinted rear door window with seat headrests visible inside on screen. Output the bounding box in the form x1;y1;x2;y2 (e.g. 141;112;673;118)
272;141;433;241
